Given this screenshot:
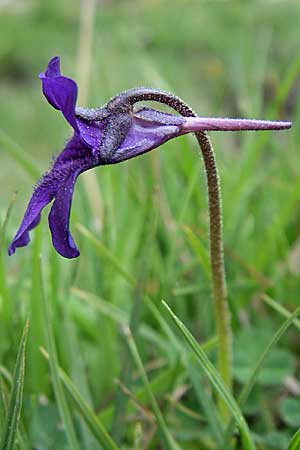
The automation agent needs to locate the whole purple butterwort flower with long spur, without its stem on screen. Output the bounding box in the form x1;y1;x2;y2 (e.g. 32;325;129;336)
8;57;291;258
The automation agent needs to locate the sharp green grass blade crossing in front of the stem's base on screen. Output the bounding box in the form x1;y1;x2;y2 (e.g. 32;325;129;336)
163;302;255;450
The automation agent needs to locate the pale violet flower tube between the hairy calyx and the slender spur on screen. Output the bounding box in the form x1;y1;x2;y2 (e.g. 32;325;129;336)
111;108;185;163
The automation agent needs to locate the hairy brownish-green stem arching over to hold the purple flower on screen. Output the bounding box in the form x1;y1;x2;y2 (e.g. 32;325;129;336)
118;88;232;419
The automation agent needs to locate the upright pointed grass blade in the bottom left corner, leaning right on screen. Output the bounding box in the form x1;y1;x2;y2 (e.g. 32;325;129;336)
0;322;29;450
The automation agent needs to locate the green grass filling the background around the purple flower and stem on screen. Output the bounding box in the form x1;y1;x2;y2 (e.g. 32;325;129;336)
0;0;300;450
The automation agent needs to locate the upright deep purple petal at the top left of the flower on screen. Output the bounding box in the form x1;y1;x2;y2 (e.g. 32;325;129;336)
39;56;79;133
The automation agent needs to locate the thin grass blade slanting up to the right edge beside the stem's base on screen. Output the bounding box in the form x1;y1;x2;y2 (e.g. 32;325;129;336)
225;302;300;444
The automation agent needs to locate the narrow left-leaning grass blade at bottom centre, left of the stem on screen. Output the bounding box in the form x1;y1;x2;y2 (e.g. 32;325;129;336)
123;327;180;450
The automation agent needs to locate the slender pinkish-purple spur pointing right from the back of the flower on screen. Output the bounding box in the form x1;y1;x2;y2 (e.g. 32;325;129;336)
182;117;292;133
